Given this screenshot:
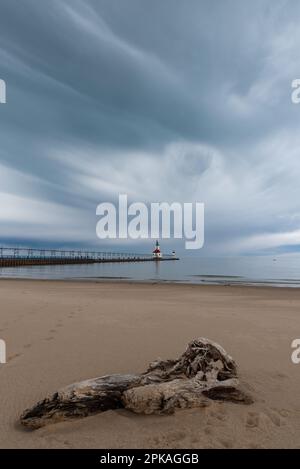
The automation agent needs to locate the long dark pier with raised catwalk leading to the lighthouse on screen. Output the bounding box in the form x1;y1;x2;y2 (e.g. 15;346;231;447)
0;247;179;267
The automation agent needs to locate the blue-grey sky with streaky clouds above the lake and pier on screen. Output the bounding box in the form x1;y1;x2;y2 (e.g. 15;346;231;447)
0;0;300;256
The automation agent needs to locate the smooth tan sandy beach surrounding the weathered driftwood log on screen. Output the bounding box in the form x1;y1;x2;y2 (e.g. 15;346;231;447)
0;280;300;448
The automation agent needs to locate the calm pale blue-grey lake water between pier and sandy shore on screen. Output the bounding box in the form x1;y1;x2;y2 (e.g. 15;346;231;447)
0;254;300;287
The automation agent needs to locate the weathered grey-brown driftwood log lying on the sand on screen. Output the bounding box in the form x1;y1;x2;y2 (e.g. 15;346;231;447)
21;338;253;429
